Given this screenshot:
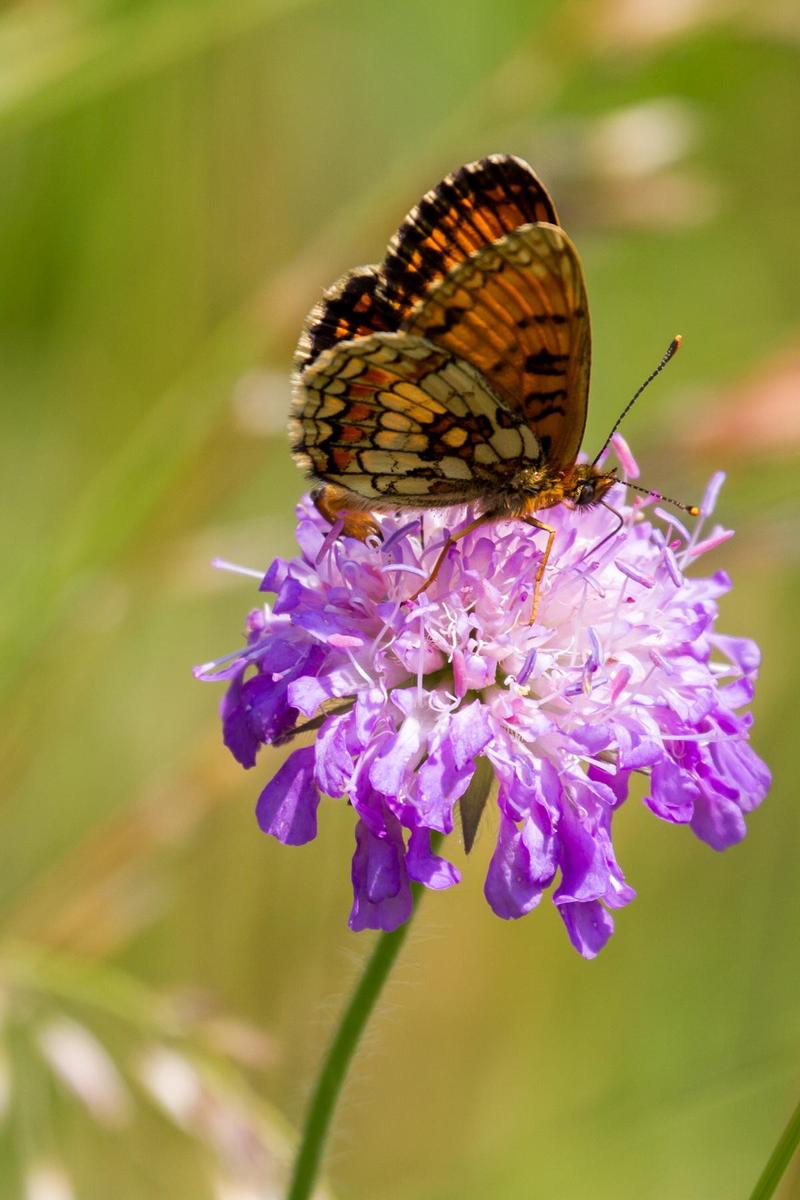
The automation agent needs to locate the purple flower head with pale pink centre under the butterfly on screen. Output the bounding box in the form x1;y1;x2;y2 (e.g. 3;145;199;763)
197;448;770;958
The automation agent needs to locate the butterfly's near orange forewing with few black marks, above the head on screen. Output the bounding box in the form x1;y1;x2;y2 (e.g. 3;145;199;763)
403;224;591;468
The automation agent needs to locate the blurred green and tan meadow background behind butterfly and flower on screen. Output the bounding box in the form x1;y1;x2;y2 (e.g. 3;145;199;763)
0;0;800;1200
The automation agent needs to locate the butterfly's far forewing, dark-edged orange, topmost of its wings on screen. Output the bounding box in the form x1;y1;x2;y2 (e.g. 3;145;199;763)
380;155;559;316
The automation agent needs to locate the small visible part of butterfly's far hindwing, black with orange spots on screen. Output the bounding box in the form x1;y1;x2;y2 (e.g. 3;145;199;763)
295;266;398;371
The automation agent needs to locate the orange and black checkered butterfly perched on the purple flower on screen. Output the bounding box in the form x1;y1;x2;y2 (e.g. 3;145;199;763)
289;155;686;622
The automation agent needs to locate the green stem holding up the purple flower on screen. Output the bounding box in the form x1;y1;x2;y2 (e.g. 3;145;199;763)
287;883;425;1200
